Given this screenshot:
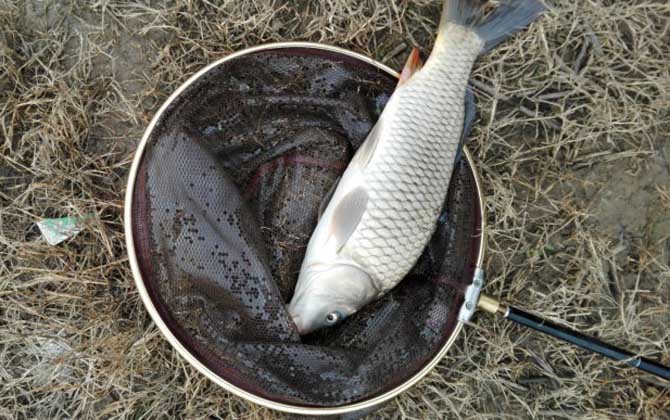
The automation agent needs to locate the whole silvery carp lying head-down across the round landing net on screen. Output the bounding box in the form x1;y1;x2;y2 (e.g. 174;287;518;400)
287;0;545;335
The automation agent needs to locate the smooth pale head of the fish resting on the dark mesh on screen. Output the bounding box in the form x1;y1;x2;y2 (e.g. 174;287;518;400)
288;264;378;335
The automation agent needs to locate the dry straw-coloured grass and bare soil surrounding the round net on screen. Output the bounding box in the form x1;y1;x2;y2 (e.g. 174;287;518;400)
0;0;670;419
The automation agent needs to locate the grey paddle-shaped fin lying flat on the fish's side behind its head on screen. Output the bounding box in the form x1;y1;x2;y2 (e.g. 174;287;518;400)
330;187;368;252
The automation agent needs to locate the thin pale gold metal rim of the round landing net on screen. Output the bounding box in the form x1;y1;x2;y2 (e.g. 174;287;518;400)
124;42;486;415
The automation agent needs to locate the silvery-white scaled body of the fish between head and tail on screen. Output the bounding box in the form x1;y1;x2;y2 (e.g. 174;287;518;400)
343;27;482;292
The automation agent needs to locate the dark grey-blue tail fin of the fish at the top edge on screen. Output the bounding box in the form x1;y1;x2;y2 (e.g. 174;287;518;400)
439;0;546;54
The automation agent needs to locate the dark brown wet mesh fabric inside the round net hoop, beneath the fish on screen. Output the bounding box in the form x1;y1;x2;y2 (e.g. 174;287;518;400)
132;49;481;407
